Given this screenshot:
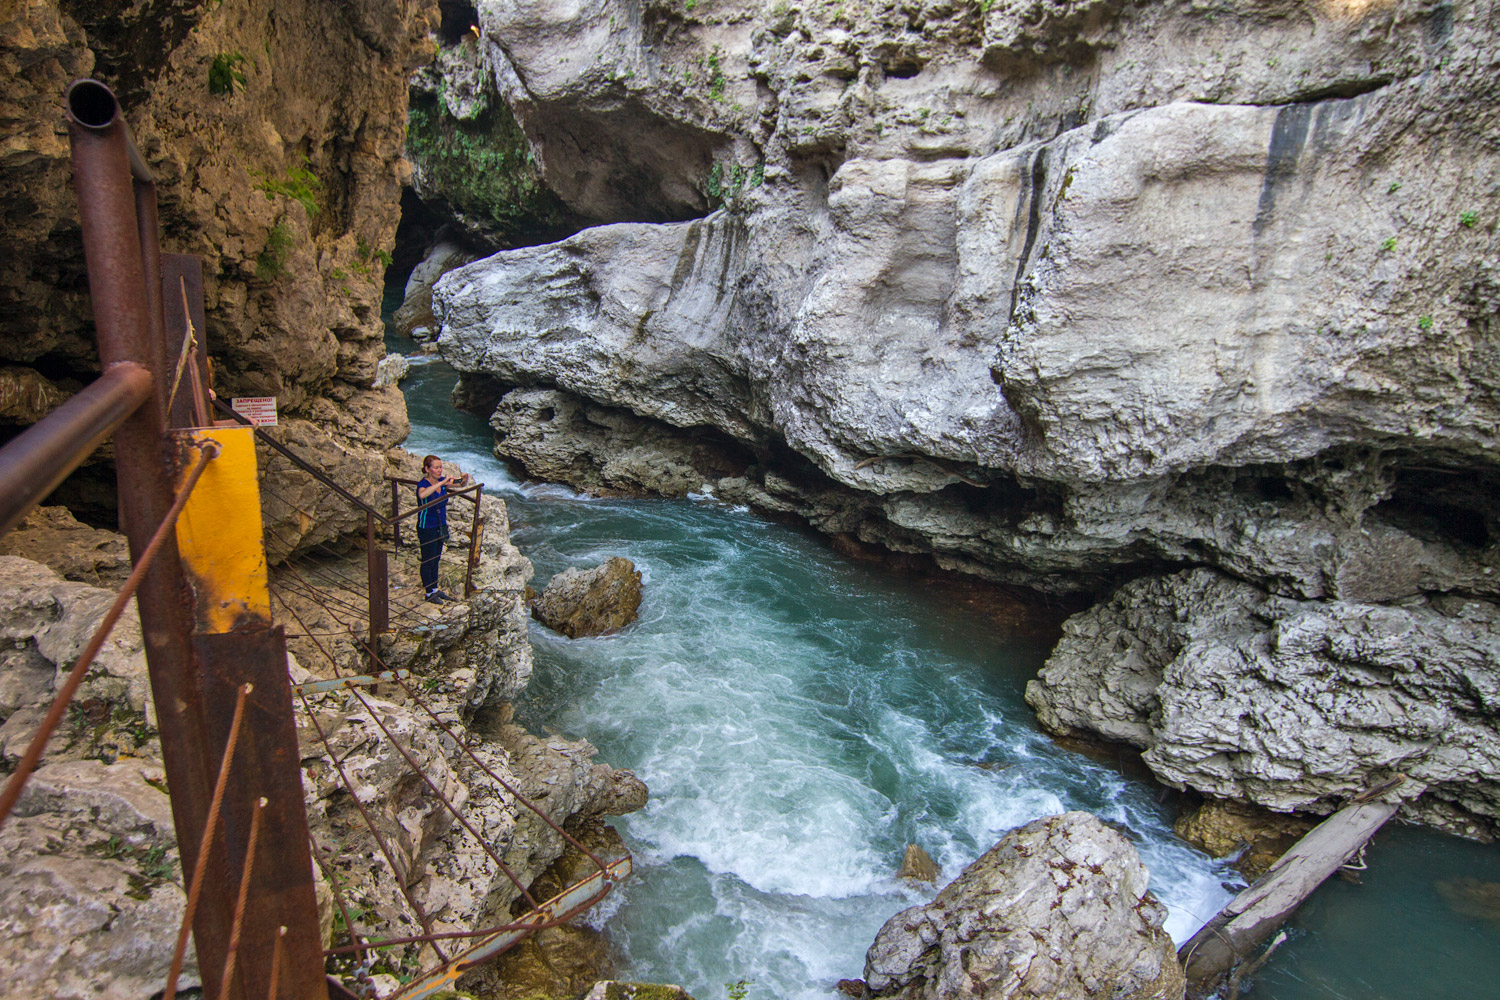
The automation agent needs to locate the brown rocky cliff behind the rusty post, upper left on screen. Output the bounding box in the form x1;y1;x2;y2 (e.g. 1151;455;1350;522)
0;0;435;541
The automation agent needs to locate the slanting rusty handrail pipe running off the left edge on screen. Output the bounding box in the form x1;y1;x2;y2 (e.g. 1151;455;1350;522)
0;363;152;535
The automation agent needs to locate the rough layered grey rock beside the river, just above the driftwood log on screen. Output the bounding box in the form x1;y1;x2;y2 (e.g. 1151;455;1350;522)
1026;570;1500;837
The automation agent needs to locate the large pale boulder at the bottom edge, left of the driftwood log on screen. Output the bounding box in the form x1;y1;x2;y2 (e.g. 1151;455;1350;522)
864;813;1185;1000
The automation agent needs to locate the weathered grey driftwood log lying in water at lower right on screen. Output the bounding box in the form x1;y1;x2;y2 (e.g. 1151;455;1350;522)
1178;778;1422;982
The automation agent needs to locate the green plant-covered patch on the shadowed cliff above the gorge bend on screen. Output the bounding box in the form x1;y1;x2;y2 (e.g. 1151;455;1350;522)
407;94;569;244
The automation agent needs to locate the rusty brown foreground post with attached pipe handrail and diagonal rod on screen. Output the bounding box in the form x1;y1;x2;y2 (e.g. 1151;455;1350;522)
0;79;327;1000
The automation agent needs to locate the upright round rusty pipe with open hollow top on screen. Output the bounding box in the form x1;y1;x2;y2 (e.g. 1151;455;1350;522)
66;79;233;995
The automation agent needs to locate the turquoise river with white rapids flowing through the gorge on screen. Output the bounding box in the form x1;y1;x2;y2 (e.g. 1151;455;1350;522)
390;325;1500;1000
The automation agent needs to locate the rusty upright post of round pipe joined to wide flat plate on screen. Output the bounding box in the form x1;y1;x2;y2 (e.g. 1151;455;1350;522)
66;79;327;1000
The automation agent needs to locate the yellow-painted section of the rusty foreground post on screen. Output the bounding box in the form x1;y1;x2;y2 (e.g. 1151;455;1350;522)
173;427;272;634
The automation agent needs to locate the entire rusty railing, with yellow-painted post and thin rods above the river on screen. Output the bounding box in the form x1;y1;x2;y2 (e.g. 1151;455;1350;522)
0;72;630;1000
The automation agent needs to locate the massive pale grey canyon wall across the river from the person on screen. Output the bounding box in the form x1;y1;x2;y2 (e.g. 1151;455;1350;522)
434;0;1500;832
